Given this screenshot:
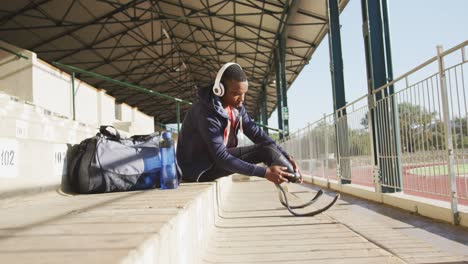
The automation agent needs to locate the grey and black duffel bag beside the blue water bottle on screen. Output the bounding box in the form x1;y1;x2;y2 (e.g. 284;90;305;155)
67;126;161;193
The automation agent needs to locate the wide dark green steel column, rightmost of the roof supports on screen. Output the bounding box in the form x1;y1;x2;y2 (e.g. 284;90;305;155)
361;0;402;192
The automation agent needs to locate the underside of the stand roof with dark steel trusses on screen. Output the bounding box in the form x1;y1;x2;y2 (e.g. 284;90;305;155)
0;0;348;123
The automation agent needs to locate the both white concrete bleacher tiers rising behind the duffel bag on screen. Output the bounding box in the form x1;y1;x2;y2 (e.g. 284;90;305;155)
0;41;154;197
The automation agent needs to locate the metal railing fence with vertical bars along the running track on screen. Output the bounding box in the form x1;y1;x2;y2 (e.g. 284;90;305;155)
282;41;468;223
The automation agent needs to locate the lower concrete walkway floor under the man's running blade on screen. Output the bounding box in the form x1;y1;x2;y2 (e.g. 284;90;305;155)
203;178;468;264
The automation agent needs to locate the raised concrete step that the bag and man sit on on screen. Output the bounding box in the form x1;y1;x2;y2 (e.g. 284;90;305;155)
0;180;217;264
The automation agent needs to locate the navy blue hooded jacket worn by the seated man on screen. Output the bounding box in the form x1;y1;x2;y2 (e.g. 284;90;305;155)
177;86;288;181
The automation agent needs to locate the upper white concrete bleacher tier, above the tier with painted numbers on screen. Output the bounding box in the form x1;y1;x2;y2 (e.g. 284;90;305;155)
0;41;154;134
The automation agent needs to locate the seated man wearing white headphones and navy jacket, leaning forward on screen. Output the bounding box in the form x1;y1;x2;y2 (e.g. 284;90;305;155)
177;63;302;184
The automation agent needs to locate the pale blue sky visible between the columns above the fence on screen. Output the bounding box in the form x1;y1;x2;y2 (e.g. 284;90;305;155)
268;0;468;132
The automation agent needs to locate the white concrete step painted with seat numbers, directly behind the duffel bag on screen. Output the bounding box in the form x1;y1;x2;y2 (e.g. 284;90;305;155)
0;93;140;197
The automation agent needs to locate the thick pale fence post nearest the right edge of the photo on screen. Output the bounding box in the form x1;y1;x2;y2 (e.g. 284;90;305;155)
437;46;460;225
